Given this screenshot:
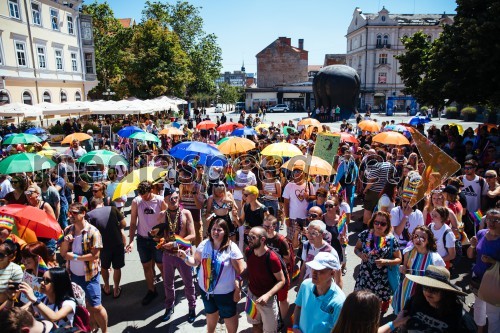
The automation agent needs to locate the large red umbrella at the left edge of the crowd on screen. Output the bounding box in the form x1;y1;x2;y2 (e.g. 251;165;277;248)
0;204;62;239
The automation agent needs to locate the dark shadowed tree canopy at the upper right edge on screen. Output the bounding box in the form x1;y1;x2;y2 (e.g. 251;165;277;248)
398;0;500;106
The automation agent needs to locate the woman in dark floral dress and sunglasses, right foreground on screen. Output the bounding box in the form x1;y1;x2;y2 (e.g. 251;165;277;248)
354;212;401;314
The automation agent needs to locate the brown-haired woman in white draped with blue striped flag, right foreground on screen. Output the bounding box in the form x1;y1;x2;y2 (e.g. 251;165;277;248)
392;225;445;314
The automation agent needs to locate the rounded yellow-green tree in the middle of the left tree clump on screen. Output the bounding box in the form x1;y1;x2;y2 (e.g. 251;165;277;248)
124;20;193;98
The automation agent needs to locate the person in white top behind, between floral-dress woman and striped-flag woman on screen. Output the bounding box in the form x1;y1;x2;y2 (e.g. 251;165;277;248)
391;189;424;251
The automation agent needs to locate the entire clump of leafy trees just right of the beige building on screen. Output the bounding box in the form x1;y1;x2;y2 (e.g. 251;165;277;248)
83;1;222;99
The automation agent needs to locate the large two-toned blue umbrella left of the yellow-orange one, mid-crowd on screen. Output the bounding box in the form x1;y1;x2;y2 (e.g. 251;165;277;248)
170;141;227;166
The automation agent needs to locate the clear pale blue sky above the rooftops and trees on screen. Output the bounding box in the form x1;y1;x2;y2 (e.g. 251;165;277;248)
94;0;456;73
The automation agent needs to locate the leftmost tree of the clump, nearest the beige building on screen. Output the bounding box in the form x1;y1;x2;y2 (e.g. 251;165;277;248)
82;2;132;99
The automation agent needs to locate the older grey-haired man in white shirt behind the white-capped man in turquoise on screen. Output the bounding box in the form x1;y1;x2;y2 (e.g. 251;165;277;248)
299;217;343;289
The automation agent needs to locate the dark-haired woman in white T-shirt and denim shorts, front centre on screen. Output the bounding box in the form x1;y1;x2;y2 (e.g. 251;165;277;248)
178;218;246;333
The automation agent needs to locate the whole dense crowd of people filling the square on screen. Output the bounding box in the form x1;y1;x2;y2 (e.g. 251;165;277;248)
0;107;500;333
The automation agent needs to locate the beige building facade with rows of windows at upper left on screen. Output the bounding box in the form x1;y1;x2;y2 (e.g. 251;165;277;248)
0;0;98;105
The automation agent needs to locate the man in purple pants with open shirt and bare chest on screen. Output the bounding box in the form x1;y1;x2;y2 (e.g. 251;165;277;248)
159;188;196;323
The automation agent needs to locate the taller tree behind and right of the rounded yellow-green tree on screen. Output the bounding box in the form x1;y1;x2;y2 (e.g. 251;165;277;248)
142;1;222;96
